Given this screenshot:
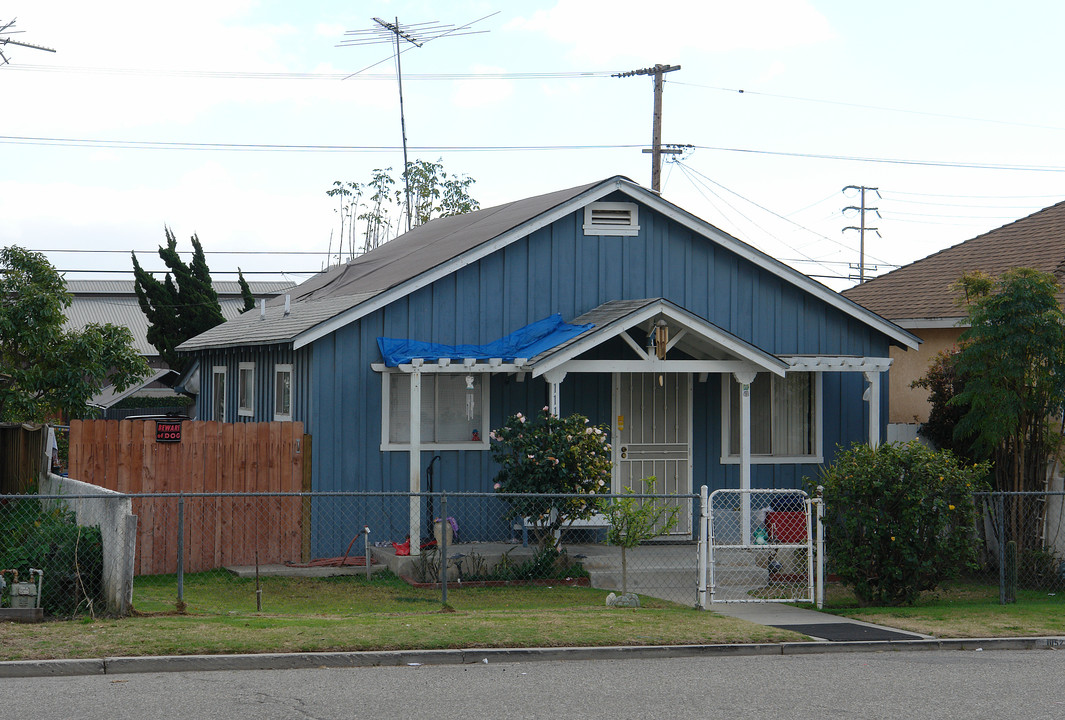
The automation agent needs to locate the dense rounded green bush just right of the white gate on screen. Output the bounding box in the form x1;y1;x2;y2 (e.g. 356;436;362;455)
820;441;988;606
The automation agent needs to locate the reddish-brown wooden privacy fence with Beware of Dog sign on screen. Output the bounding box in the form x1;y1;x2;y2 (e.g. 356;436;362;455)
69;420;310;575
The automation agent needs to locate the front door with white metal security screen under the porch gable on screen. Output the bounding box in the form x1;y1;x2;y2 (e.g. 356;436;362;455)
613;373;691;536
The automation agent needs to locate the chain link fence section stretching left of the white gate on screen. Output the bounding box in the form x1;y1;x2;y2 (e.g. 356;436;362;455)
0;492;715;617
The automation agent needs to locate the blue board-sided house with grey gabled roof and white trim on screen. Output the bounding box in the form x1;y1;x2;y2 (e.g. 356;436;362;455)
180;177;919;553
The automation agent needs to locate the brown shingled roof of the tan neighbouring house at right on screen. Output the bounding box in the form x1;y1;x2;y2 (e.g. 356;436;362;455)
842;197;1065;326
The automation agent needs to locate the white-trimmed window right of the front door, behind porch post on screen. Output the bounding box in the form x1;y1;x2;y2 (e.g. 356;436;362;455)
722;373;821;462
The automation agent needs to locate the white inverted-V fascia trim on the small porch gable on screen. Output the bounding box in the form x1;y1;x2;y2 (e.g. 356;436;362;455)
533;300;787;377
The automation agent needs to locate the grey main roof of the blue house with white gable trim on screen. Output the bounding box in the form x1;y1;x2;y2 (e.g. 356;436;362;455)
179;176;919;351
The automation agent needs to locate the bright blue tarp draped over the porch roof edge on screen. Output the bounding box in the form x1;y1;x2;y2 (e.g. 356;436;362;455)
377;313;594;367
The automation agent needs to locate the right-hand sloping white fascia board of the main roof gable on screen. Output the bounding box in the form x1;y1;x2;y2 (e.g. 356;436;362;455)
619;184;921;349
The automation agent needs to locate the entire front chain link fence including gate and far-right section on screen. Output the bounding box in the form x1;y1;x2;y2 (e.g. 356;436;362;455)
12;483;1065;617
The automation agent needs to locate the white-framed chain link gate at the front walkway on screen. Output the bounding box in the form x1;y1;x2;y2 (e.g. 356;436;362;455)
700;490;824;607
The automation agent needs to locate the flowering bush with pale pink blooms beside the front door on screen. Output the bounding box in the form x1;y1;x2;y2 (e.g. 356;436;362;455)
489;408;612;545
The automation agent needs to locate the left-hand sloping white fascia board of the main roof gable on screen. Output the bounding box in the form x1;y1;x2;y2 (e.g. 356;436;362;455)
292;178;622;350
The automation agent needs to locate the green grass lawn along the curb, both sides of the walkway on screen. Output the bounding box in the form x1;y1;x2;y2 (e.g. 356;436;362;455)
0;573;1065;660
